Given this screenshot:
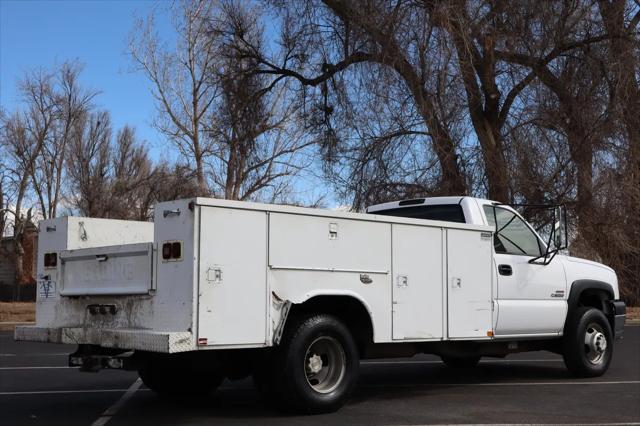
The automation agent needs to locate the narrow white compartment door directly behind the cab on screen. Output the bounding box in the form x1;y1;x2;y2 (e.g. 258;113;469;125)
447;229;493;339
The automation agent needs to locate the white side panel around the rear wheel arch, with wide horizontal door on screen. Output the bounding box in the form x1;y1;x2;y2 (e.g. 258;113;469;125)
269;212;391;341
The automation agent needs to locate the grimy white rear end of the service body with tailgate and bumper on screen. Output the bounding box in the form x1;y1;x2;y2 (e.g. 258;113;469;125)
26;200;197;352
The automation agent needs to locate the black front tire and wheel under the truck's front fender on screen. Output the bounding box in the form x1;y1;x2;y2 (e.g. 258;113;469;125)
562;307;613;377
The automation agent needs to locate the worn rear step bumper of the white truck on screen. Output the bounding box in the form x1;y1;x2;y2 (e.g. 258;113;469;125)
14;326;196;353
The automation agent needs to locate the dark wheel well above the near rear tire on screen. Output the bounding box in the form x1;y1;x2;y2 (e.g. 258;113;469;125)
287;296;373;353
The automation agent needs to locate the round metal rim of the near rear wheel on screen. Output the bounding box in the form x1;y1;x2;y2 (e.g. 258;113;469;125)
304;336;347;394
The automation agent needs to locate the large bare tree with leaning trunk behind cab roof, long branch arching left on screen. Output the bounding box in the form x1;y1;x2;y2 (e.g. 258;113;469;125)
222;0;467;200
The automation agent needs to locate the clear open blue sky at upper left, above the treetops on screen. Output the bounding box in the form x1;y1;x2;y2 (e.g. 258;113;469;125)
0;0;170;159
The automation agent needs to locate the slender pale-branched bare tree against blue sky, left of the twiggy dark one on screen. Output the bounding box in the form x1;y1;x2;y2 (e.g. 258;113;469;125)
129;0;218;195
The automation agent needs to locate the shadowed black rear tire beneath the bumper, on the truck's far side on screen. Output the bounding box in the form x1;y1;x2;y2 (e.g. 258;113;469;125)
138;355;224;397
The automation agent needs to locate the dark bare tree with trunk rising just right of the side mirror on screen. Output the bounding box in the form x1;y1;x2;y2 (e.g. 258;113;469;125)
495;4;608;237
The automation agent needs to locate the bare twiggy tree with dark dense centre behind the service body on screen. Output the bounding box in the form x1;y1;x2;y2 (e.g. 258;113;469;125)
207;2;314;201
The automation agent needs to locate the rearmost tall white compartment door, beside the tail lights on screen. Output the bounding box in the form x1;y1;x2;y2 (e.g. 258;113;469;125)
198;207;267;345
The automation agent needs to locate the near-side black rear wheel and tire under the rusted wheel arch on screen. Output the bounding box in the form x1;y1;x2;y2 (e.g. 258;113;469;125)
268;314;360;414
